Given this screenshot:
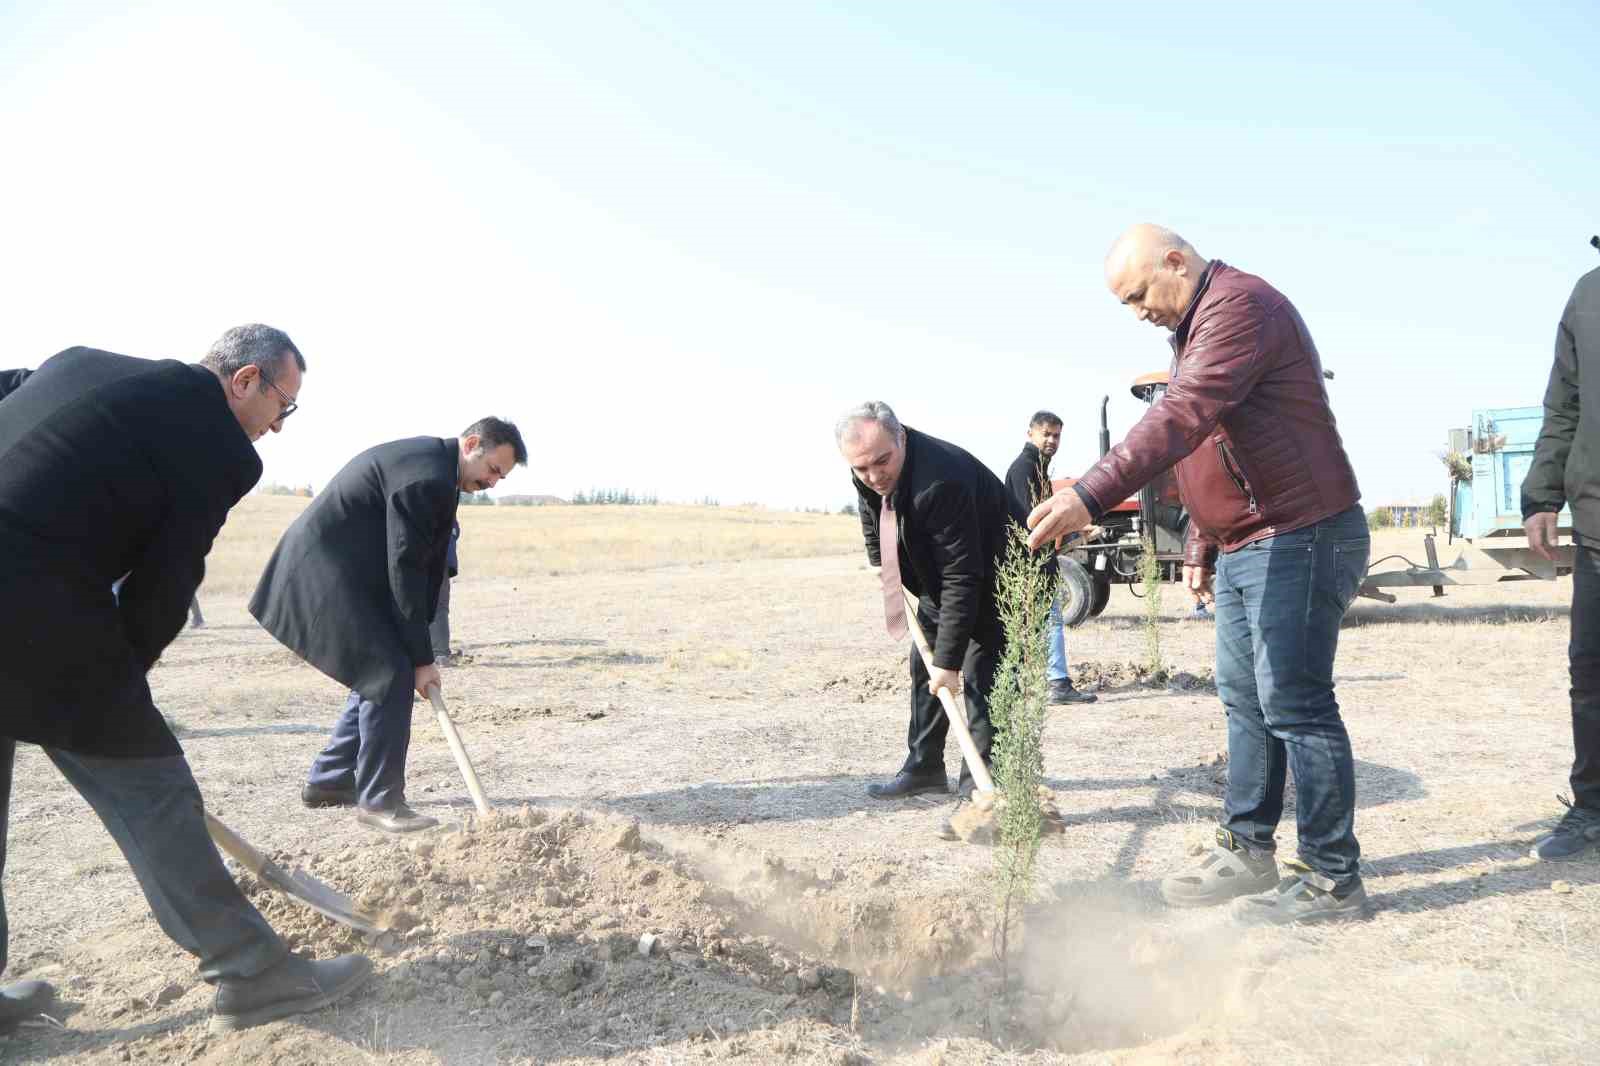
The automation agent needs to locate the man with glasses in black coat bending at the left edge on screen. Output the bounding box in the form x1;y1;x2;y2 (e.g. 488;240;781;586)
0;325;371;1029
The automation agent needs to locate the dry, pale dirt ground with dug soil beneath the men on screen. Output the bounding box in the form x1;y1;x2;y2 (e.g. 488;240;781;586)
0;515;1600;1066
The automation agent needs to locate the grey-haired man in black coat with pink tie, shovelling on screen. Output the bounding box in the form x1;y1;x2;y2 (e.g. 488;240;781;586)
834;402;1027;799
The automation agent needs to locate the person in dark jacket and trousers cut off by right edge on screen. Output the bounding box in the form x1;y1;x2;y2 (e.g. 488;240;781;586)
1522;246;1600;860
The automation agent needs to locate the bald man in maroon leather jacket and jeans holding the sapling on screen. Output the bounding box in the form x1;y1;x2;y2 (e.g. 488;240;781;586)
1029;226;1370;922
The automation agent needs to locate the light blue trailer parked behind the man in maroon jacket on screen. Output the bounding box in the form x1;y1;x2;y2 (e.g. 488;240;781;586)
1360;407;1574;603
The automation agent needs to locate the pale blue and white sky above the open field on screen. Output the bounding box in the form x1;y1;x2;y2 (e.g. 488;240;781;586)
0;0;1600;507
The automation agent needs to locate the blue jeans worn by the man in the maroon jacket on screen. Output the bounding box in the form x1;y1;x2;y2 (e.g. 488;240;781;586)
1216;506;1371;885
